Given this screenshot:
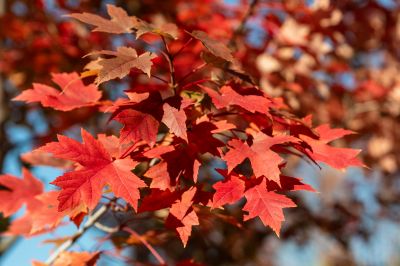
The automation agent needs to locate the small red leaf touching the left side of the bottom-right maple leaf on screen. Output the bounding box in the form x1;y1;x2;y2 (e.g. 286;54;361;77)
211;175;245;208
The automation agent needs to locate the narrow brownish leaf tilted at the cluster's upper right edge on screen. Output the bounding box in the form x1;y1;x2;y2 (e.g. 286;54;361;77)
189;30;235;63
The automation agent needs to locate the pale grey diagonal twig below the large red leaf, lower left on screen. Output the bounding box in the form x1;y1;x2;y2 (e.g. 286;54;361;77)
46;205;109;265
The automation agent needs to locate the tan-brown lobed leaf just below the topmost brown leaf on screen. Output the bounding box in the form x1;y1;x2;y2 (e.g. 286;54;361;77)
95;46;157;85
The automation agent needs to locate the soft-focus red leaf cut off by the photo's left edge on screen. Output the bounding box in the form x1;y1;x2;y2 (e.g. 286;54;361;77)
0;168;43;217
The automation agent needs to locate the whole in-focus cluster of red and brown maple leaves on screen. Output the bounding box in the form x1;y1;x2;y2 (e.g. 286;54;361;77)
0;5;363;265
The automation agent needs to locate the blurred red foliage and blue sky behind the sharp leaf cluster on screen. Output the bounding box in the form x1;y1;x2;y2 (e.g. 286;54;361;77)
0;0;400;265
